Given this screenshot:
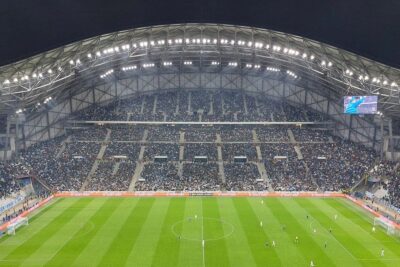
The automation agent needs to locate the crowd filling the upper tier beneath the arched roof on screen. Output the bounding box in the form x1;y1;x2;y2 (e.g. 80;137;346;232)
70;90;328;121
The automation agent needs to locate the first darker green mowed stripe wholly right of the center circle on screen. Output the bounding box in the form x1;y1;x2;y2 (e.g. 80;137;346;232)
233;198;282;266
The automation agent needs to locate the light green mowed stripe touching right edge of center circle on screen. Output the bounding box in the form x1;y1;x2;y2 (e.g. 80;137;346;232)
218;198;257;267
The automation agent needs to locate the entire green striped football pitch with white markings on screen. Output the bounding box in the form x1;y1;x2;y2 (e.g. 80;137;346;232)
0;197;400;267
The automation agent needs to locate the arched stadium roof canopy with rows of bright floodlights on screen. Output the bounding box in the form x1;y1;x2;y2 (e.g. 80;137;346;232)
0;23;400;116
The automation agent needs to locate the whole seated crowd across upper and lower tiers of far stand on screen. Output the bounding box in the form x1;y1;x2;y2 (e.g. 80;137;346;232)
0;91;398;204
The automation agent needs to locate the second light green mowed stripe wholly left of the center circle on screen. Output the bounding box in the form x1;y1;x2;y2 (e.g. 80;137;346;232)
72;198;139;267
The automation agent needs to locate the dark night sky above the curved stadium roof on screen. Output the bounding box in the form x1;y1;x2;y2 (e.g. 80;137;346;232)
0;0;400;67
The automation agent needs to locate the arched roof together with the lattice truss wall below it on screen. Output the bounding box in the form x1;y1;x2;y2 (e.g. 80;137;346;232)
0;24;400;159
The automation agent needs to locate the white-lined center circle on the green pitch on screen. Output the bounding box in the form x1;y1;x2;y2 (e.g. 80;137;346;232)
171;216;235;242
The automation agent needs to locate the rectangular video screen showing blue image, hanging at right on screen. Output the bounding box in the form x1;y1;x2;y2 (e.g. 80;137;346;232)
343;95;378;114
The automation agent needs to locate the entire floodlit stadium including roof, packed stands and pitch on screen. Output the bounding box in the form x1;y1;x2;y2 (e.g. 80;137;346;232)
0;6;400;266
